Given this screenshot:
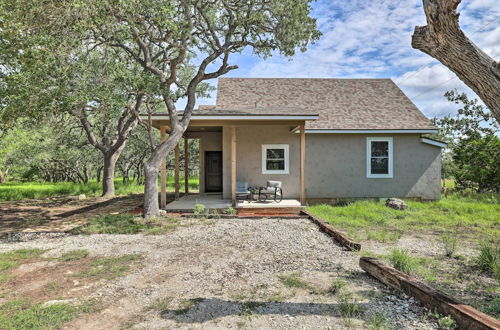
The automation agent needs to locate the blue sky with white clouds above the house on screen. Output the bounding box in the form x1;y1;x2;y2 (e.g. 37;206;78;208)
189;0;500;118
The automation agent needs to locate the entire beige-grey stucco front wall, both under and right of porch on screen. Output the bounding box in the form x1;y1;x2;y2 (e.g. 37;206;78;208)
222;126;441;199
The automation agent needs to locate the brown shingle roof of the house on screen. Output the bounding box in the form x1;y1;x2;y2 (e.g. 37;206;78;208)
213;78;436;130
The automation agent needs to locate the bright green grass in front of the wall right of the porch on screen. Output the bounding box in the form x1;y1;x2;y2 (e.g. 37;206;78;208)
308;194;500;242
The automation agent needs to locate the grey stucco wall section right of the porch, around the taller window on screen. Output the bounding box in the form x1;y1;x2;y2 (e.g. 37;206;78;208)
306;134;441;199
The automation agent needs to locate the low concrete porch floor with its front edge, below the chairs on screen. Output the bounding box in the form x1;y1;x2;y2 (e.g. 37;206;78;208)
164;193;301;214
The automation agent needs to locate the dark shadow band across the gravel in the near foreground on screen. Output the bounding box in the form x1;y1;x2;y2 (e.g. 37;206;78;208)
161;298;368;323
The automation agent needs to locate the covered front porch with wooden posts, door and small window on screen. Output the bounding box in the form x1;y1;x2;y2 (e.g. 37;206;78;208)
140;110;317;211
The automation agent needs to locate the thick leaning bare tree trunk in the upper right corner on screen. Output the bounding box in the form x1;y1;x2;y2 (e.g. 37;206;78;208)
412;0;500;122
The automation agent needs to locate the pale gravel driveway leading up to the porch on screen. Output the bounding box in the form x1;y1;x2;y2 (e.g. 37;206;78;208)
0;219;437;329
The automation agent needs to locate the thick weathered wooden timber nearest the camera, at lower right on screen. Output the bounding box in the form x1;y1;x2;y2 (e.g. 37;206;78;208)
359;257;500;330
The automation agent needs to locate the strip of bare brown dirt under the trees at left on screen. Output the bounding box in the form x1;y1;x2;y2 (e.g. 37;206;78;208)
0;194;143;236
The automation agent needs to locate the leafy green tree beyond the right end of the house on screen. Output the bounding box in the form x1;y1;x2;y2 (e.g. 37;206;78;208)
434;91;500;192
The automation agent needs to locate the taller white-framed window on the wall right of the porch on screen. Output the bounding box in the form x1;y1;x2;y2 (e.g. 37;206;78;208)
366;137;392;178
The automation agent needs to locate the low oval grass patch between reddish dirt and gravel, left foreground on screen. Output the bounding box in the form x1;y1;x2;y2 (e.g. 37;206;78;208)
74;254;141;280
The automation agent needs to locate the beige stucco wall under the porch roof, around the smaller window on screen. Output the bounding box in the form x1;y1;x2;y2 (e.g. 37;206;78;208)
222;126;300;198
